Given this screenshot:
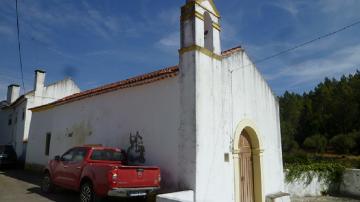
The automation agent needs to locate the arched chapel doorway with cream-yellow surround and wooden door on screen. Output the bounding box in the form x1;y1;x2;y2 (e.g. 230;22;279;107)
233;120;265;202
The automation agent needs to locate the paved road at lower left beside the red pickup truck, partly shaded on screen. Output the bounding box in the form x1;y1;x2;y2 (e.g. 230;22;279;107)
0;170;151;202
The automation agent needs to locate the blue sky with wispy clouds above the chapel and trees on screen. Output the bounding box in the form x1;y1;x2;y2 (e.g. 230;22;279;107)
0;0;360;99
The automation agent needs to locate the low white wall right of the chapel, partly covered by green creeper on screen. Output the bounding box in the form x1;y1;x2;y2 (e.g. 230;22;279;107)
285;169;360;197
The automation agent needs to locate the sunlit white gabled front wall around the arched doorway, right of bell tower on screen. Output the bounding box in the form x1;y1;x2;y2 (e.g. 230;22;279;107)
207;51;284;201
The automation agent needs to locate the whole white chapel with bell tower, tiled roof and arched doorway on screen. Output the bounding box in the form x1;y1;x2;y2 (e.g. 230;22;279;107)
27;0;284;202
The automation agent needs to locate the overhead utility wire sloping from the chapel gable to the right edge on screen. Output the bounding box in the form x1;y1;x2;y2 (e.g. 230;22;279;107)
231;20;360;72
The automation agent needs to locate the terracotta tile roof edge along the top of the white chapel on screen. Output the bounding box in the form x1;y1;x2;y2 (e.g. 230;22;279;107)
30;46;242;111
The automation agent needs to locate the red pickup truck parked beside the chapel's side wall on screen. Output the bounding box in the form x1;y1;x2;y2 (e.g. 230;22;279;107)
41;146;161;202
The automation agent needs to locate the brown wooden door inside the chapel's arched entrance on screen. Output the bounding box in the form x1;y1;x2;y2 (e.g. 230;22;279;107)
240;131;254;202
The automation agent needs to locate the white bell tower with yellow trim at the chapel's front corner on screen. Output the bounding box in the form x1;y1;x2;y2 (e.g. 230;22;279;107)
178;0;225;201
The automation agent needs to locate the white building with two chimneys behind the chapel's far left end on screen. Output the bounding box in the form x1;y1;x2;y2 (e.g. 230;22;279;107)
0;70;80;161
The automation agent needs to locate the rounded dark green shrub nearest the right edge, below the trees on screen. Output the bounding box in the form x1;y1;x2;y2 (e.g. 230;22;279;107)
330;133;356;154
